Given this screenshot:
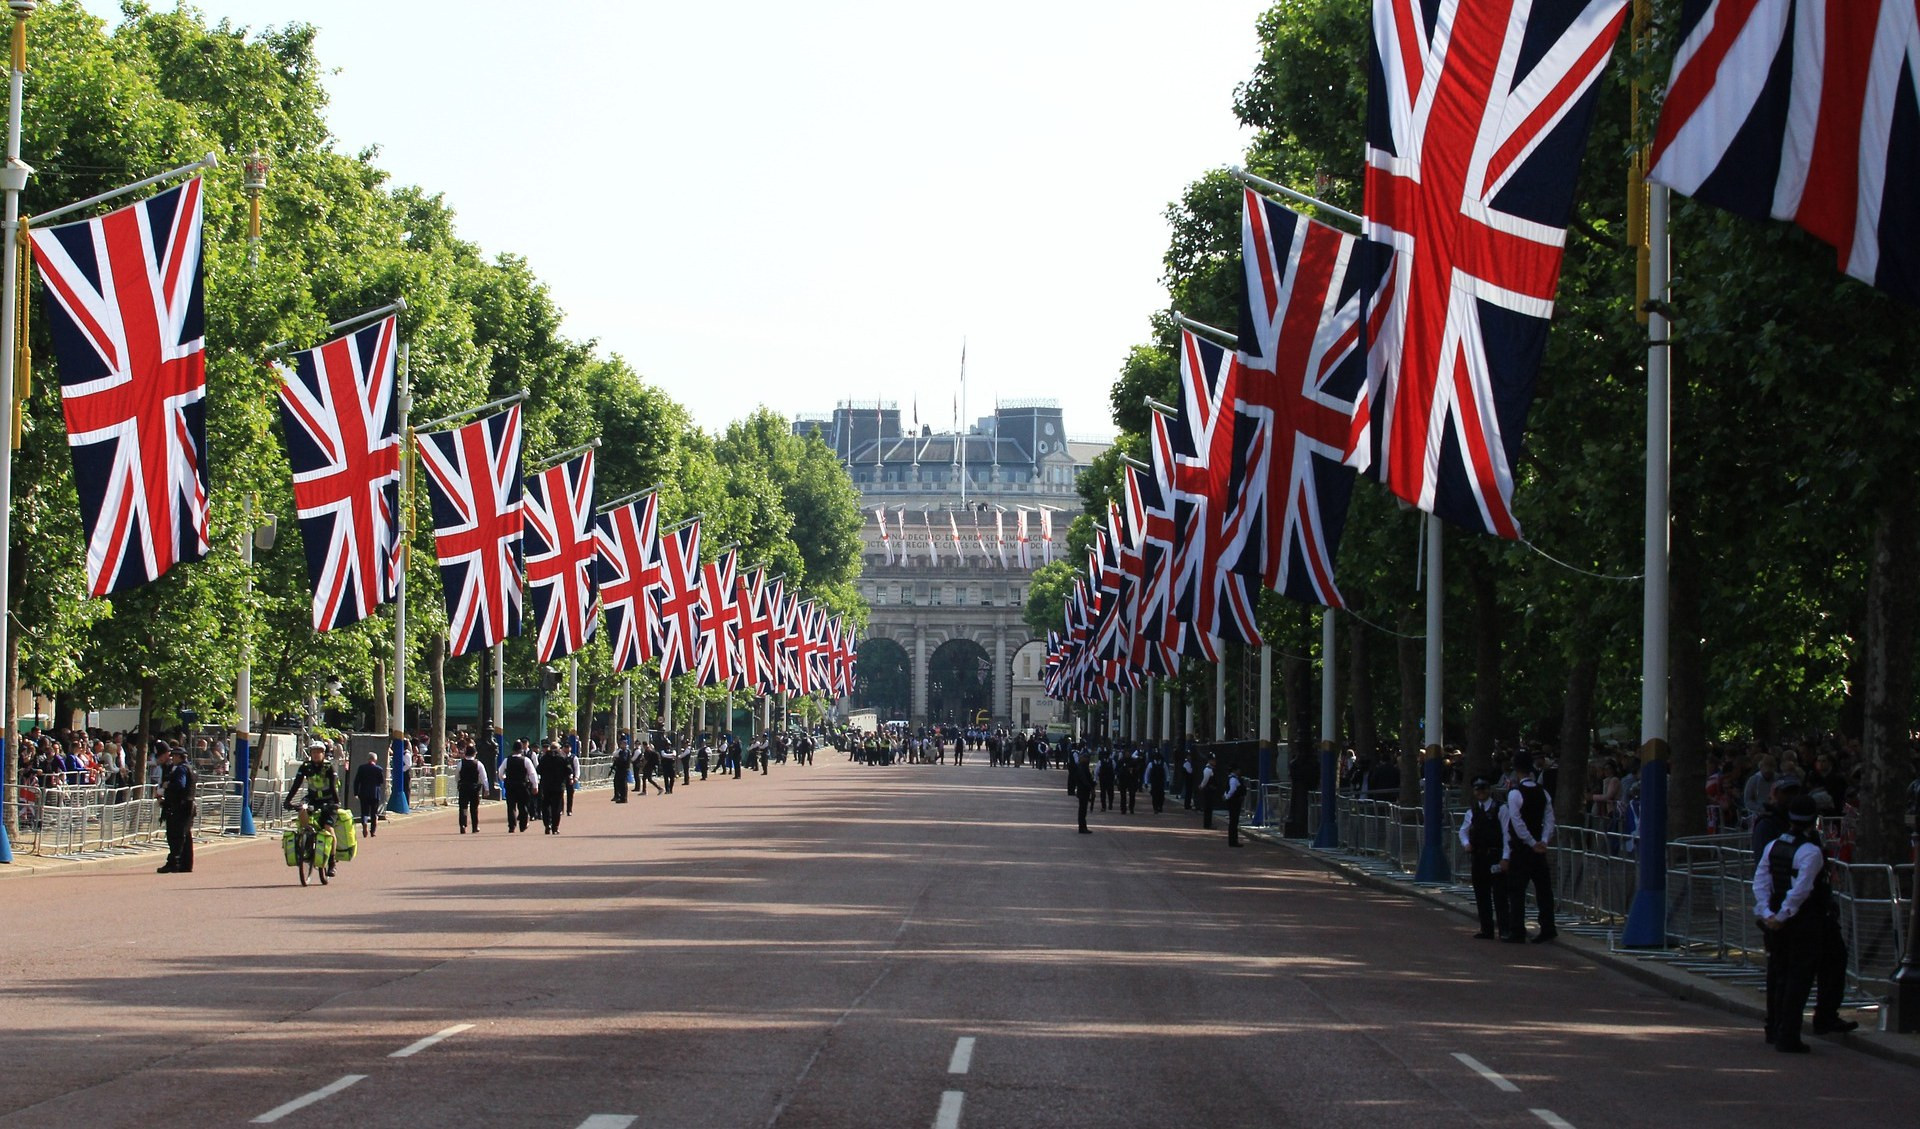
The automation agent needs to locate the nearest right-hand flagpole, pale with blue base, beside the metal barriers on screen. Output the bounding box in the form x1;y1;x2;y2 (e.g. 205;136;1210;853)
1620;184;1674;949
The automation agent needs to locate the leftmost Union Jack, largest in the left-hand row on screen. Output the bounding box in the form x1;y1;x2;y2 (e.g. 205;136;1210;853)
33;177;209;595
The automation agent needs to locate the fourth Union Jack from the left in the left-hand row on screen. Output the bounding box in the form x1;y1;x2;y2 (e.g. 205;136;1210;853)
526;451;599;662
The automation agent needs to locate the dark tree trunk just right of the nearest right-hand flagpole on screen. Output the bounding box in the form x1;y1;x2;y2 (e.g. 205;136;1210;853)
1667;507;1707;839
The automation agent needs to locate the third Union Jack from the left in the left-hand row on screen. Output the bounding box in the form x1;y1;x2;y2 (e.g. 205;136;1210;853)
420;403;524;655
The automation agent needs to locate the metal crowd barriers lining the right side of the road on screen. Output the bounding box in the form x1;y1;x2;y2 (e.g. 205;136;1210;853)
1256;783;1914;1000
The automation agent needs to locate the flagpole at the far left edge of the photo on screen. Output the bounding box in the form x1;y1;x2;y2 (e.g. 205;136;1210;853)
0;0;38;862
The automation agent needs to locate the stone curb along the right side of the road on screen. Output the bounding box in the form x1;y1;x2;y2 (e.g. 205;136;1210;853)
1240;828;1920;1068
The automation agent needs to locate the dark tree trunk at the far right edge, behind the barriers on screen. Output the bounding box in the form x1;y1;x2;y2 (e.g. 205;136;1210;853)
1855;468;1916;862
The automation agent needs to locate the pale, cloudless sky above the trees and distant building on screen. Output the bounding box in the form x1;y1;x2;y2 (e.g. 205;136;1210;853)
82;0;1271;436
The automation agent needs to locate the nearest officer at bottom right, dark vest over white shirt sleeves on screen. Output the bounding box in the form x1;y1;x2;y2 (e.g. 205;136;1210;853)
1753;795;1859;1054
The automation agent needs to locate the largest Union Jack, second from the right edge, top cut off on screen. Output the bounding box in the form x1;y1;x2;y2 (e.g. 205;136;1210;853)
1354;0;1626;538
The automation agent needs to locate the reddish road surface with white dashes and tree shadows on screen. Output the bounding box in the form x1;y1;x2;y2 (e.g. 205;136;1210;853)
0;751;1920;1129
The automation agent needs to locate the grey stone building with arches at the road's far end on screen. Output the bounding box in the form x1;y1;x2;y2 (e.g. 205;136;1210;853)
793;399;1108;726
